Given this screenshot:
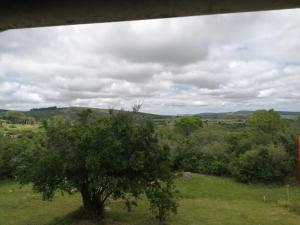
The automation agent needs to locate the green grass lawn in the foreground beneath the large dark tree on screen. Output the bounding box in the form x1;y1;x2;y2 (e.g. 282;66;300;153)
0;175;300;225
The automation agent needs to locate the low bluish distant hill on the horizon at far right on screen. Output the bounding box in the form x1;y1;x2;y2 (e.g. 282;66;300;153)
195;111;300;119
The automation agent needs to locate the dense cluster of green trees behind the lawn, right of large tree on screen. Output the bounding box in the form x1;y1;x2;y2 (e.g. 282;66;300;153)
162;110;297;183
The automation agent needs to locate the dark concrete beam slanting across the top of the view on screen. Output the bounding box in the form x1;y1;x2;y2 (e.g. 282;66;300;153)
0;0;300;30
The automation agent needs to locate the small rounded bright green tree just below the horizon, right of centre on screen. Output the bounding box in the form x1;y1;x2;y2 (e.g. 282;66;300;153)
175;116;203;136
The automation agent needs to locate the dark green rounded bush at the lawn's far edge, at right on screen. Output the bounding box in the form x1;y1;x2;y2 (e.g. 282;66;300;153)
232;144;290;183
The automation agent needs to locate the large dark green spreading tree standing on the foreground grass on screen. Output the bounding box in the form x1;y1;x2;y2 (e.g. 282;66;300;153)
20;110;173;217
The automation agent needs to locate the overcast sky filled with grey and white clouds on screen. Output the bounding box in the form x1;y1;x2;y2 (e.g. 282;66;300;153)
0;9;300;115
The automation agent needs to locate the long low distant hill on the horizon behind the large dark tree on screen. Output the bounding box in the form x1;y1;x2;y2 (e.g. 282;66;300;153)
0;106;170;120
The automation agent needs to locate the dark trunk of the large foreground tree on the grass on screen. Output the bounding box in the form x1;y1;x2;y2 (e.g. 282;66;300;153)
81;184;104;218
